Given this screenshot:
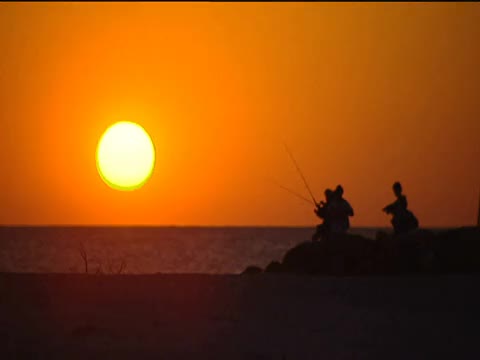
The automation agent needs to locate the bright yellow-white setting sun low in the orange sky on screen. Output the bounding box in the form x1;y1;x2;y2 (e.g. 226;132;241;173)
96;121;155;191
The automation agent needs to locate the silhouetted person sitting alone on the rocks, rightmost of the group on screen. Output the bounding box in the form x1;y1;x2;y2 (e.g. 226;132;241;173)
382;181;418;235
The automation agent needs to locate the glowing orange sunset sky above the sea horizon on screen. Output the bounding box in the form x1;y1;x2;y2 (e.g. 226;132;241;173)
0;2;480;226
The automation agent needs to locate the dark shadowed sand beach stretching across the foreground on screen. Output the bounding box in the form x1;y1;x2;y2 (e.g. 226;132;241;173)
0;274;480;360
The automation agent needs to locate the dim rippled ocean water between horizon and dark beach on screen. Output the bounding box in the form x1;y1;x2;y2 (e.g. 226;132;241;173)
0;227;383;274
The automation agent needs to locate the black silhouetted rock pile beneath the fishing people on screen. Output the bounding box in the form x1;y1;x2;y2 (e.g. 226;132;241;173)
245;227;480;276
